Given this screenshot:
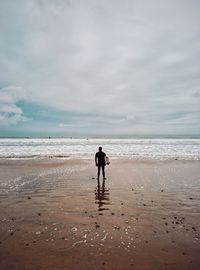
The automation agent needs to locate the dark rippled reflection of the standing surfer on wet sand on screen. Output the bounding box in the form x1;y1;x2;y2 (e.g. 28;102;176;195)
95;180;110;211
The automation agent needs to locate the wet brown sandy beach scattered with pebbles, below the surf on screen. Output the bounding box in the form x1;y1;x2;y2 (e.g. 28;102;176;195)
0;159;200;270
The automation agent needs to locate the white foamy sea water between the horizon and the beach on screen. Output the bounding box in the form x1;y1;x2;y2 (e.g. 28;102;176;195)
0;138;200;160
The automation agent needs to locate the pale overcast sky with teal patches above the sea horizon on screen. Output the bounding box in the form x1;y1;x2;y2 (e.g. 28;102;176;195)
0;0;200;137
